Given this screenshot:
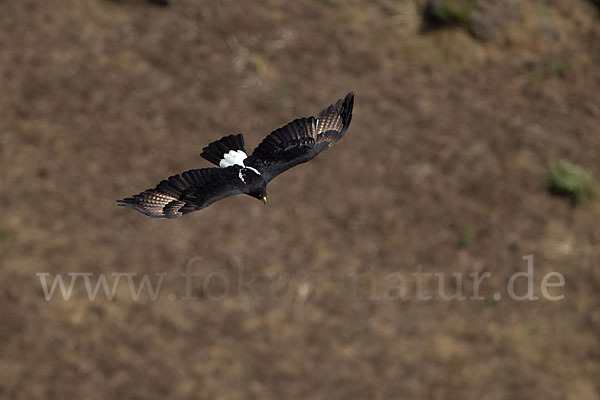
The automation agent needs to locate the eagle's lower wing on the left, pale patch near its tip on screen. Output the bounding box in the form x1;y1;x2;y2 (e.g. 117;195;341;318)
117;166;247;218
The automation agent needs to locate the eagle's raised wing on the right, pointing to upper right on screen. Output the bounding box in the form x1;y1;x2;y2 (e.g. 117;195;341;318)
244;92;354;181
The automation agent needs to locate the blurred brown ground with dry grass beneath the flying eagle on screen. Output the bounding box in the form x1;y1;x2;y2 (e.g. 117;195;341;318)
0;0;600;400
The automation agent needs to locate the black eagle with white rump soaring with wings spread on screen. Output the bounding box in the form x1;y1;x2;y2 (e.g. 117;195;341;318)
117;92;354;218
